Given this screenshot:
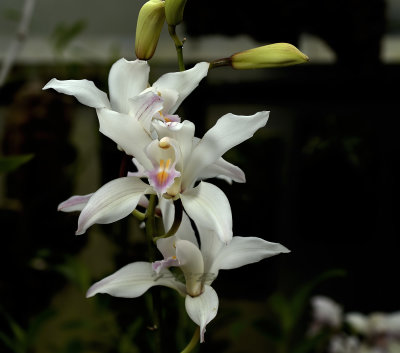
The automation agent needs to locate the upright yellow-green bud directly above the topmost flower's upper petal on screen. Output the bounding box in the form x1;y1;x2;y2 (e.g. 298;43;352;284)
135;0;165;60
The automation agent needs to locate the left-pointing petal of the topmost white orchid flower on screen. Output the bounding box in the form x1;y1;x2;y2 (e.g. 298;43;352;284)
43;78;110;108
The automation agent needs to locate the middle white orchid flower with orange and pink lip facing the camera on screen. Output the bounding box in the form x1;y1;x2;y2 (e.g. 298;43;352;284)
59;109;269;243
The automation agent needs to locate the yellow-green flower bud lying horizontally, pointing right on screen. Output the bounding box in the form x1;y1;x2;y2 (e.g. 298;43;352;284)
230;43;309;70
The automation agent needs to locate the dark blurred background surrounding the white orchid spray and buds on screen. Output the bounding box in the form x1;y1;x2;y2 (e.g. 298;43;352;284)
0;0;400;353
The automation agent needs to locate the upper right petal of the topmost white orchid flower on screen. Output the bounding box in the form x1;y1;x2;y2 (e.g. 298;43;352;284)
153;62;210;114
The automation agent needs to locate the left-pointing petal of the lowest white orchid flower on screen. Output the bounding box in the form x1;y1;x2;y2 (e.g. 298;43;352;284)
86;262;185;298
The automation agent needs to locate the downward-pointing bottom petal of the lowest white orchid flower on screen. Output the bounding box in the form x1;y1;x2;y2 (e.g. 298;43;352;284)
185;285;219;342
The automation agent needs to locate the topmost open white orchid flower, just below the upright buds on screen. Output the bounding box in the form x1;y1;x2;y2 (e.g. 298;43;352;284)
43;58;209;132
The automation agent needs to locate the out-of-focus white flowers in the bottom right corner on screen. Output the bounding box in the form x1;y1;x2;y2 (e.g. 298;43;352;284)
310;296;400;353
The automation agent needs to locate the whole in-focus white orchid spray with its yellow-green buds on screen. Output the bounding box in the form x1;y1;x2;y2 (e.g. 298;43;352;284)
43;0;308;342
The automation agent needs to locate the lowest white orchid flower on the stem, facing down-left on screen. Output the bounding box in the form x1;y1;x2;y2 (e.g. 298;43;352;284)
87;212;289;342
